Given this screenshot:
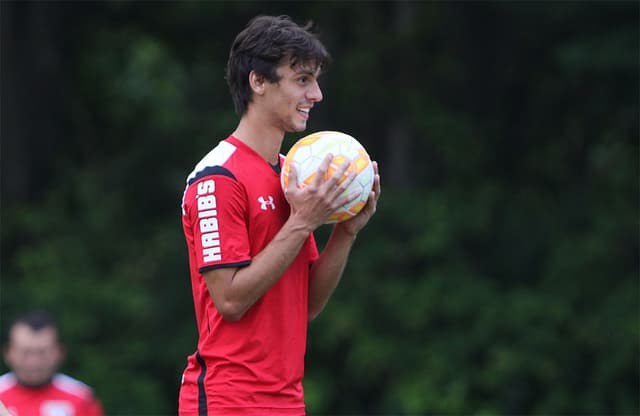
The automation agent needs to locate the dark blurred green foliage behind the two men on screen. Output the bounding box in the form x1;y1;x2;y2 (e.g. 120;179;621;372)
0;1;640;415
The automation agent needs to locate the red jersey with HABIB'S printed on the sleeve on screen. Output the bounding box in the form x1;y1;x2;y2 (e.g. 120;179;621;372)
179;136;318;416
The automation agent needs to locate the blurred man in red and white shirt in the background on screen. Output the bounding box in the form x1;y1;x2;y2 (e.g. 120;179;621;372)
0;312;103;416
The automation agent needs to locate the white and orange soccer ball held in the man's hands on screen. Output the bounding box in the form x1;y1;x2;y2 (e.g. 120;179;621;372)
280;131;374;224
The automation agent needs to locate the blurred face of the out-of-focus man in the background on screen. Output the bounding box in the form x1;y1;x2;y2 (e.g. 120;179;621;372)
5;324;63;386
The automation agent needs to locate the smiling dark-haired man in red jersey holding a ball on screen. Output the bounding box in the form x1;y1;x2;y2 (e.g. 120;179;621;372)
179;16;380;416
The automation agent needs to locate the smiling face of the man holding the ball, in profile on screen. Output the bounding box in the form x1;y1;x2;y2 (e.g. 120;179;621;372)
265;63;322;132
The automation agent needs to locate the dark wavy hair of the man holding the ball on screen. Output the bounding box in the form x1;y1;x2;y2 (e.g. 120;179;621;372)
226;16;331;116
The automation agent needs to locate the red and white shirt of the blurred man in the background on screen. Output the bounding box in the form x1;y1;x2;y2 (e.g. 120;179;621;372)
0;373;103;416
